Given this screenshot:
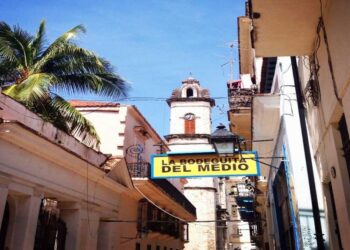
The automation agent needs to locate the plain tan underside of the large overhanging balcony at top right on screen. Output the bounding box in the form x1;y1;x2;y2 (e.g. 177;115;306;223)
249;0;320;57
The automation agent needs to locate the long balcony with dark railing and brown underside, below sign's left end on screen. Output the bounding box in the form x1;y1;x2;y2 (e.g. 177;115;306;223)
128;162;196;221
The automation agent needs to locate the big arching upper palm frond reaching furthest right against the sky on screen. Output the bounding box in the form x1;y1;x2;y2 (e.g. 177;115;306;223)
34;43;129;98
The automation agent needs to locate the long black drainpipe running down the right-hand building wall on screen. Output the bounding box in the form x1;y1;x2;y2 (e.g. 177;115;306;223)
290;56;325;250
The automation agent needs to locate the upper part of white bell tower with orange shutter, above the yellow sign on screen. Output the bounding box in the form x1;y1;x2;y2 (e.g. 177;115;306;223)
165;76;215;152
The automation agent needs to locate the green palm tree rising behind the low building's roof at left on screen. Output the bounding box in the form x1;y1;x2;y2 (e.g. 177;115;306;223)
0;21;128;146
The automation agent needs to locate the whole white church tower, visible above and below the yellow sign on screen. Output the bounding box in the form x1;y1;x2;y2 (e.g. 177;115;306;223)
165;77;217;250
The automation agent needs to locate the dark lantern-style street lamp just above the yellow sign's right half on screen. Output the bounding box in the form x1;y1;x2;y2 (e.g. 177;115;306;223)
210;123;240;155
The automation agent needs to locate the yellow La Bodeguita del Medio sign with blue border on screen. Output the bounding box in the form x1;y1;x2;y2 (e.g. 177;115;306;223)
152;151;260;178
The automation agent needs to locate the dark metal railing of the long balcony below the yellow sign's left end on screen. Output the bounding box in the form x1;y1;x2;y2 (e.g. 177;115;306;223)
128;162;196;215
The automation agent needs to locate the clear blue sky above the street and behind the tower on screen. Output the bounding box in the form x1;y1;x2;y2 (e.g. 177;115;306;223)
0;0;245;136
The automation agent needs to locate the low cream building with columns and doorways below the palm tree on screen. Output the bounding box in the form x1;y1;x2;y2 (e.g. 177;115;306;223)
0;94;132;249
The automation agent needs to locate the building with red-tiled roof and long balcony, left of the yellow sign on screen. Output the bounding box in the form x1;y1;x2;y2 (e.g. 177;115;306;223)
71;101;196;250
